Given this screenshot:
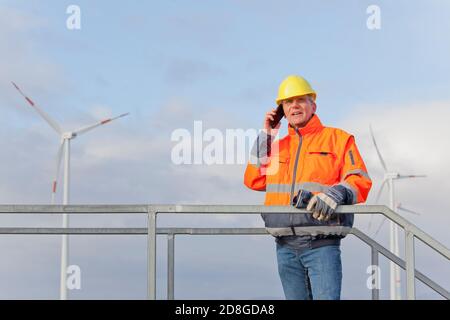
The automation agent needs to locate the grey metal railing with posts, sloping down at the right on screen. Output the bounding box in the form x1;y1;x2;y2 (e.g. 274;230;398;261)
0;205;450;299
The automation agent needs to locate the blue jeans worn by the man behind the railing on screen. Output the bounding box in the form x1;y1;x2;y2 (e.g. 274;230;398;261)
277;244;342;300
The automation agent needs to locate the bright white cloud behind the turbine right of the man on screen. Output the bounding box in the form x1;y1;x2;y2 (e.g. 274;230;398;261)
339;101;450;225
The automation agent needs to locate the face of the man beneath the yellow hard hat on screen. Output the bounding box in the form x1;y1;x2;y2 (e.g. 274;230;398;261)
282;95;316;128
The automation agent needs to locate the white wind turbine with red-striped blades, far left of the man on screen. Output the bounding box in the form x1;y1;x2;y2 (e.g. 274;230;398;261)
12;82;129;300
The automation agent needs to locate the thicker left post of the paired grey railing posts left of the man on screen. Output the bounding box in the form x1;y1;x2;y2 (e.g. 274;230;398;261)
147;210;156;300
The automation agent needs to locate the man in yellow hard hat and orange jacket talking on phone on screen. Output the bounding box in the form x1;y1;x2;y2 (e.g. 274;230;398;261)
244;76;372;300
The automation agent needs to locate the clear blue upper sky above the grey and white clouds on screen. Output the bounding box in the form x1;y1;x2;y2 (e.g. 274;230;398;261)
5;1;450;125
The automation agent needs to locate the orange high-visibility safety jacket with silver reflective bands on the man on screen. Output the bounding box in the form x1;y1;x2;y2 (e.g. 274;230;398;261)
244;115;372;238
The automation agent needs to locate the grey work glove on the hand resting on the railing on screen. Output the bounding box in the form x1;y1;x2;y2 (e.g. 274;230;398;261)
306;185;353;221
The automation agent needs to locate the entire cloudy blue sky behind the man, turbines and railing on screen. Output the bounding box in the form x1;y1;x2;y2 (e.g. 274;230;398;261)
0;0;450;299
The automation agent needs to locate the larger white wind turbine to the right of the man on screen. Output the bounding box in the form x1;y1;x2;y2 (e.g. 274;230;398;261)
369;126;426;300
